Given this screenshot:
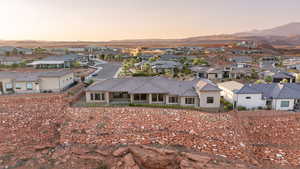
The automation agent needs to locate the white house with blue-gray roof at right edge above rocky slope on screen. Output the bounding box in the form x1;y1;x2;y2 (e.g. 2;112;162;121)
235;83;300;110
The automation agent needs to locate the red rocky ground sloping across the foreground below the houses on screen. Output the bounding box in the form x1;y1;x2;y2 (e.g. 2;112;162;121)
0;94;300;169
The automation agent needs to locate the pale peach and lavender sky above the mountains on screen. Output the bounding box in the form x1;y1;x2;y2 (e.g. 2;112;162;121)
0;0;300;41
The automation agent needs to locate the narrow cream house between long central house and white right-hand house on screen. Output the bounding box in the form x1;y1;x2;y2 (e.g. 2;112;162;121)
218;81;244;106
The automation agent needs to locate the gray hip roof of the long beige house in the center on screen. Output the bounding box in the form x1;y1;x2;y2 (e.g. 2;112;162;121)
87;77;219;96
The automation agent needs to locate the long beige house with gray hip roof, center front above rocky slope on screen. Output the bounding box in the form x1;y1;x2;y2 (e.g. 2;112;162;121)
86;77;220;111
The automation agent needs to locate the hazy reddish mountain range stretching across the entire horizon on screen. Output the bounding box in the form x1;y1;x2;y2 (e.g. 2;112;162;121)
0;22;300;48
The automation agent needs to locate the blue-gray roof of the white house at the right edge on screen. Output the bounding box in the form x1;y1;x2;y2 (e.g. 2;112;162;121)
237;83;300;99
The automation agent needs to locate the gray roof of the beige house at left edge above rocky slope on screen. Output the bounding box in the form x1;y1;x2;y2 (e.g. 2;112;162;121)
0;71;72;82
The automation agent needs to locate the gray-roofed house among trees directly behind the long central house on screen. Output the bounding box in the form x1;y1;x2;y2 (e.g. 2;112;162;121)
149;60;183;73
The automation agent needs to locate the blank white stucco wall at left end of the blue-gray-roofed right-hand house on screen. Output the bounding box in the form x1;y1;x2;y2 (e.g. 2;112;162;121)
236;94;266;109
